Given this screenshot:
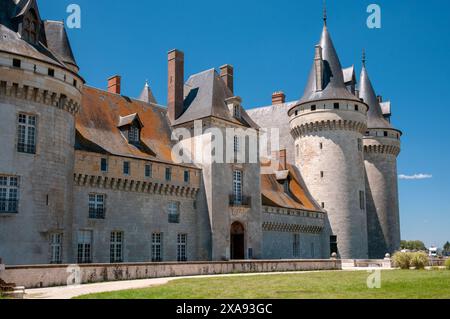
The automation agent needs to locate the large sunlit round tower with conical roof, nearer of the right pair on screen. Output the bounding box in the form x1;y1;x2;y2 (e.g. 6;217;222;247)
288;20;368;258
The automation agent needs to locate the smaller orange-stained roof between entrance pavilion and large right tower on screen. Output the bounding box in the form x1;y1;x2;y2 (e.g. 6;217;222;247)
261;164;323;211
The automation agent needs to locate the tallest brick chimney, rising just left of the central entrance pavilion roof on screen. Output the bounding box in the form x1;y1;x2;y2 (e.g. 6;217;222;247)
167;49;184;122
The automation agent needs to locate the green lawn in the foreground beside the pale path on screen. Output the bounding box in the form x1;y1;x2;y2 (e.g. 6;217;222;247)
79;270;450;299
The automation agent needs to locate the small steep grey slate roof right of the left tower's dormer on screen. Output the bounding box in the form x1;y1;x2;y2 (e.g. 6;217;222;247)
44;21;77;66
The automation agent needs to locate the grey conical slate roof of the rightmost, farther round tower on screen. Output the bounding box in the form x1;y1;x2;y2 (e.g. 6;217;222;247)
359;58;393;129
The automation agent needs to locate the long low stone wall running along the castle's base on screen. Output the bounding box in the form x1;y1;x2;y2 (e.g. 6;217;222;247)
0;259;342;289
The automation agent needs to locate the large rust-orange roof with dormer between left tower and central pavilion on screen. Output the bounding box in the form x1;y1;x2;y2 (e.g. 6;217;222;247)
76;86;190;163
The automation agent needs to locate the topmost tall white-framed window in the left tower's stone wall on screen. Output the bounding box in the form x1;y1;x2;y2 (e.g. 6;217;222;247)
17;113;36;154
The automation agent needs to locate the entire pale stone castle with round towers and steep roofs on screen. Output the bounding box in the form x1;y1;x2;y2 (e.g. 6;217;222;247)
0;0;401;265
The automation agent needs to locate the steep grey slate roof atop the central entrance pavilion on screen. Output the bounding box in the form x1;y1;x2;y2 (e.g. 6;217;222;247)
174;69;258;128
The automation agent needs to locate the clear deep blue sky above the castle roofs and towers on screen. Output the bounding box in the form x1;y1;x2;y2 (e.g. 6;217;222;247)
39;0;450;246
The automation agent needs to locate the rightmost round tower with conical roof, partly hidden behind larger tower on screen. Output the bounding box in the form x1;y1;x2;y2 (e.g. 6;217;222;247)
359;53;402;258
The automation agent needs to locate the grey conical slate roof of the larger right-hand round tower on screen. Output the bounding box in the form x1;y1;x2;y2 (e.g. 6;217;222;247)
298;25;359;104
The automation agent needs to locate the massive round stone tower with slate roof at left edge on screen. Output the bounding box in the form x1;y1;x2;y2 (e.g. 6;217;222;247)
0;1;84;264
